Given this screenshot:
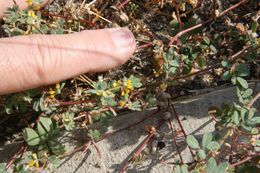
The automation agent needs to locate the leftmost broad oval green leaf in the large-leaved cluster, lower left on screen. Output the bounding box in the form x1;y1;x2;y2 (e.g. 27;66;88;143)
23;128;41;146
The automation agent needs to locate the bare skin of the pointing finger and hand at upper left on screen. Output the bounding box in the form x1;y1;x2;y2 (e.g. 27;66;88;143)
0;0;136;95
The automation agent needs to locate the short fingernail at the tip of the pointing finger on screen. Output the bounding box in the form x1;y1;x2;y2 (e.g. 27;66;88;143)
109;28;135;47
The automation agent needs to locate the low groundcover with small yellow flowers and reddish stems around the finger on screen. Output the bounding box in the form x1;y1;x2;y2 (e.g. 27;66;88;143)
0;0;260;173
